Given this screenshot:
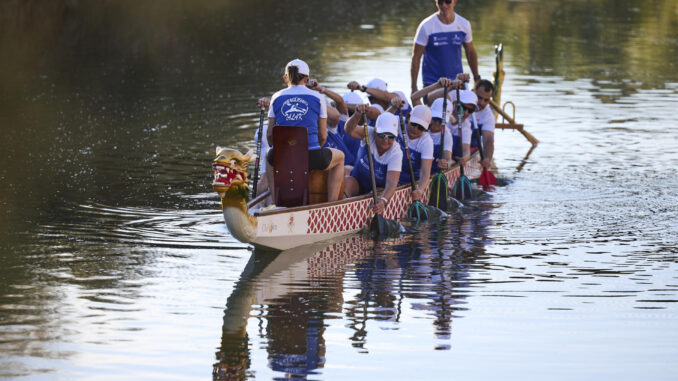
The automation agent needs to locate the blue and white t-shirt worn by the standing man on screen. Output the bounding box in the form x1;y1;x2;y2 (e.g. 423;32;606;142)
414;13;473;86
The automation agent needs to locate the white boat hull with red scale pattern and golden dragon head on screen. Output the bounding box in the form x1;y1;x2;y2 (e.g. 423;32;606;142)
212;149;482;250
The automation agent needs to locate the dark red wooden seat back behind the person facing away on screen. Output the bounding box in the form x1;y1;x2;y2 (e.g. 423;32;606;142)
273;126;309;207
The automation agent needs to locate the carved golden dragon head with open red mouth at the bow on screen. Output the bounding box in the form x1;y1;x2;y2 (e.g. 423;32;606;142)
212;147;255;198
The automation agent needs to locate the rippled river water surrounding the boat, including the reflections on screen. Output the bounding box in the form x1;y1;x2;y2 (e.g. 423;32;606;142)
0;0;678;380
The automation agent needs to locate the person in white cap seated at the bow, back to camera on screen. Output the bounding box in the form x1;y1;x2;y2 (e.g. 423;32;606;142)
266;59;344;201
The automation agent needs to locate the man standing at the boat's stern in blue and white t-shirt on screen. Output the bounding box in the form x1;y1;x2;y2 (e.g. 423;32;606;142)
410;0;480;93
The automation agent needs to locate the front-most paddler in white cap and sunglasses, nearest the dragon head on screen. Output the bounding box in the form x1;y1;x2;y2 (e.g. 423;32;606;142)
344;105;403;214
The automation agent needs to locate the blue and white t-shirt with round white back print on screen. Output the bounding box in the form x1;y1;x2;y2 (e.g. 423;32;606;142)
268;85;327;151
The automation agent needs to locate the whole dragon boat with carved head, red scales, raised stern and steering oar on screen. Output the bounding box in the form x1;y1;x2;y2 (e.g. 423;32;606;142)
212;43;539;251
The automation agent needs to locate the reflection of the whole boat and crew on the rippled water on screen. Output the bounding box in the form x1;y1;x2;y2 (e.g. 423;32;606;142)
214;206;492;379
